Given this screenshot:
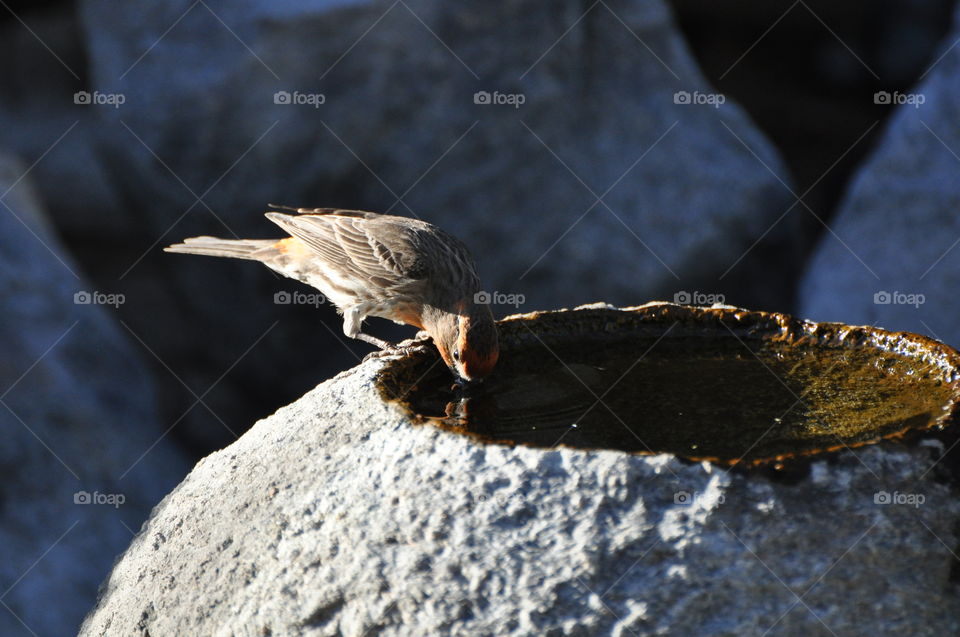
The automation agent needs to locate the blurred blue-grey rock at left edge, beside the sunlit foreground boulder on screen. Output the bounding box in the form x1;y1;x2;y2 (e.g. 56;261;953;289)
0;157;188;637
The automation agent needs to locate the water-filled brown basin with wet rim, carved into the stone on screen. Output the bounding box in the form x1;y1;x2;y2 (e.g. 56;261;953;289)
379;303;960;465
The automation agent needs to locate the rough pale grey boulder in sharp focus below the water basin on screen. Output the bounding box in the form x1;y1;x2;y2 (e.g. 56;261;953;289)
81;350;960;637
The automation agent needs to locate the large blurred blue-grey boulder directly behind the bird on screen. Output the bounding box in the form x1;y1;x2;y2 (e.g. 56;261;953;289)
75;0;794;441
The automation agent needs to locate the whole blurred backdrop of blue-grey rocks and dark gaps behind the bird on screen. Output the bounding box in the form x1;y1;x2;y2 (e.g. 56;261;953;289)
0;0;960;634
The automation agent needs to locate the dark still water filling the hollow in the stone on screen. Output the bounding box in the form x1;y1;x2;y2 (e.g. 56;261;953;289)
392;335;952;462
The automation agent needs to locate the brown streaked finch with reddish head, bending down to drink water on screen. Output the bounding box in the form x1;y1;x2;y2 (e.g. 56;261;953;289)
164;204;500;385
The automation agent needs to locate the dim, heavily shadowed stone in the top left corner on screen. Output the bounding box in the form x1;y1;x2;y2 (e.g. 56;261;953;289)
0;4;122;234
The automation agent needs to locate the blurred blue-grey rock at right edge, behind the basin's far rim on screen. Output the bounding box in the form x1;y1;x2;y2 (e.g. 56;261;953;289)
800;4;960;345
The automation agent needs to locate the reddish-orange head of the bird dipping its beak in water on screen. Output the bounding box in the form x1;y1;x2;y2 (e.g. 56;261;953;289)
429;302;500;383
